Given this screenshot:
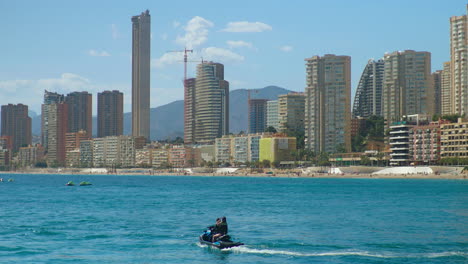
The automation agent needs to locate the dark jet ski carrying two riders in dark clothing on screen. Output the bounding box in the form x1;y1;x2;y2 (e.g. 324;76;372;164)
199;217;244;249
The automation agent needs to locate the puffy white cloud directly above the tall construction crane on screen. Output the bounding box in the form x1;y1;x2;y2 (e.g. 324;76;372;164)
176;16;214;49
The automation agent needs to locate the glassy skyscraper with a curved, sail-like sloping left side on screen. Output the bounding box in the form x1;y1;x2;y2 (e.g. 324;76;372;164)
353;60;384;118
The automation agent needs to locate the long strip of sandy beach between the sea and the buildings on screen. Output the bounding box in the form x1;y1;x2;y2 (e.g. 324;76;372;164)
0;169;468;180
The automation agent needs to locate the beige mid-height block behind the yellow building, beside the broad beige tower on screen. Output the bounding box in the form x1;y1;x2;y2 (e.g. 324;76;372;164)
278;93;305;133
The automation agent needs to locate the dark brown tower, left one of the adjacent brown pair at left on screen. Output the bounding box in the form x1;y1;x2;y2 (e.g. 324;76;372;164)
65;92;93;138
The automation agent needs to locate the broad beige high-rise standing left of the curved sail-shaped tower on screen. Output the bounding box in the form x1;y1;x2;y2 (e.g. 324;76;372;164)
305;54;351;153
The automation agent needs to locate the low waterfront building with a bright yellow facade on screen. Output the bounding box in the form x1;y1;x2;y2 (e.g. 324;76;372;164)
260;137;296;162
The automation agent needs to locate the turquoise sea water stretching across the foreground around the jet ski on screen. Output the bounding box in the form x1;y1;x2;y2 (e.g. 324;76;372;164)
0;175;468;263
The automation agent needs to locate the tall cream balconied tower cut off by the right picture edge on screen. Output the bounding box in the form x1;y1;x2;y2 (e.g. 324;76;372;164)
450;4;468;115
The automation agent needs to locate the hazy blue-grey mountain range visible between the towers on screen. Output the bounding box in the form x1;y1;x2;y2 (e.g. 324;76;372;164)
31;86;291;140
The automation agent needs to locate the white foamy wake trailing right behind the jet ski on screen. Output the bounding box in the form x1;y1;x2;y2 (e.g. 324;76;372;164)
222;246;468;258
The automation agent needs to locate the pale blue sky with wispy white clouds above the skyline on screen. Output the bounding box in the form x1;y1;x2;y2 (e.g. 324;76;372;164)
0;0;468;115
